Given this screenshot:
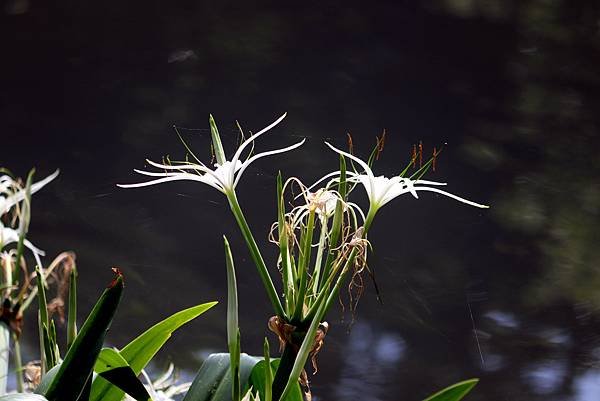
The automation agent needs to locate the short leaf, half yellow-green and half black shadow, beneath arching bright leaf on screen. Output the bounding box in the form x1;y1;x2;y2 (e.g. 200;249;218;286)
94;348;150;401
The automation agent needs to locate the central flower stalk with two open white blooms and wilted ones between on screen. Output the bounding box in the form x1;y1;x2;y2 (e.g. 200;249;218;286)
119;114;488;400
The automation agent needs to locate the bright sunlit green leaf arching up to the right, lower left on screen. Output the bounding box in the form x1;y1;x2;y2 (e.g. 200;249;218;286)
90;302;217;401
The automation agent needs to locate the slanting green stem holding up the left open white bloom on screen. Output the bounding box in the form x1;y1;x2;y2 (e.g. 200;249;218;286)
227;192;286;318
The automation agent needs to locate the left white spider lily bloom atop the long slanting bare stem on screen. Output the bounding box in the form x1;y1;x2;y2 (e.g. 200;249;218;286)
117;113;305;195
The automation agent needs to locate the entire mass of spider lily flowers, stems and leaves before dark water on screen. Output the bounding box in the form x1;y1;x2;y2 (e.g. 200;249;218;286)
0;114;487;401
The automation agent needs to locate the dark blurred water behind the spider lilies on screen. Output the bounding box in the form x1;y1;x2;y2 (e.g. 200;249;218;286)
0;0;600;401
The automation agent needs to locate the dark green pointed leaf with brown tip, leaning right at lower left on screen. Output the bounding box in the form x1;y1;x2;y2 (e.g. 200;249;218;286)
37;271;123;401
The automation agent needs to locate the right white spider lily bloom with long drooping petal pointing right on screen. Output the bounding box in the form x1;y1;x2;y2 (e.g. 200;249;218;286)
317;142;489;214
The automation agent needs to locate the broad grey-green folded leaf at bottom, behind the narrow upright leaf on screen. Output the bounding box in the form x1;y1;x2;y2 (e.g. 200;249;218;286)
183;353;262;401
